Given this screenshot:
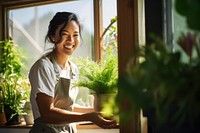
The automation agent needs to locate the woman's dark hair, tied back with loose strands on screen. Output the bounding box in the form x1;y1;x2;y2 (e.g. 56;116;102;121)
45;12;81;43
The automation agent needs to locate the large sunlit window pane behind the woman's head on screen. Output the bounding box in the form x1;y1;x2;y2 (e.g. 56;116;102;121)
9;0;94;74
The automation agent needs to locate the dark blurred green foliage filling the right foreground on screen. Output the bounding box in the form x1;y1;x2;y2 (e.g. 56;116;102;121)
119;0;200;133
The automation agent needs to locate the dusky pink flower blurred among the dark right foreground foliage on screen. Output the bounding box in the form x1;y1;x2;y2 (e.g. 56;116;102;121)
177;32;196;58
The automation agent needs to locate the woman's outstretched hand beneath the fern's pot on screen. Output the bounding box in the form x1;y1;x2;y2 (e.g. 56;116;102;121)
84;112;116;128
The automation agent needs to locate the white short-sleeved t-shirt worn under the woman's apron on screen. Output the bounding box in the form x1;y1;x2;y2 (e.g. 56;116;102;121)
29;57;78;119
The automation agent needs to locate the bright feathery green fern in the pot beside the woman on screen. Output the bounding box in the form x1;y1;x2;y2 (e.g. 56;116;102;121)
74;48;118;110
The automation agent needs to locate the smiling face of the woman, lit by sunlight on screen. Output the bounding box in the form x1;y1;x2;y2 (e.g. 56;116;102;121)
52;21;80;55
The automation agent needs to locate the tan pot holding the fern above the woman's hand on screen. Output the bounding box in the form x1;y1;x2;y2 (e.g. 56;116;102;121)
92;93;116;112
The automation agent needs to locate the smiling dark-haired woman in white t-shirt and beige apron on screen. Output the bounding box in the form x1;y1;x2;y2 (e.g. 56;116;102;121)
29;12;115;133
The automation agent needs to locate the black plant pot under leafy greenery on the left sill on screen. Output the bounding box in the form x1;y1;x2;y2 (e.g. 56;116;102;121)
4;105;21;125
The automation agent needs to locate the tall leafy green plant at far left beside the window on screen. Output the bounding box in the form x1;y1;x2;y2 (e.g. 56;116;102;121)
0;40;24;124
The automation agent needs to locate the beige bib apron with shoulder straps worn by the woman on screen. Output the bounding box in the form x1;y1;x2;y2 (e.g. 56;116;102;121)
29;52;77;133
